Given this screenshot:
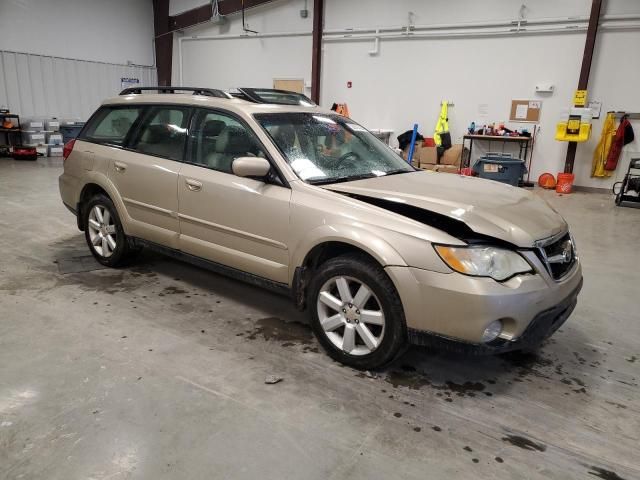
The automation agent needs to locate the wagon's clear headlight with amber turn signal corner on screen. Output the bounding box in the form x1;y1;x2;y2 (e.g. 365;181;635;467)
434;245;532;281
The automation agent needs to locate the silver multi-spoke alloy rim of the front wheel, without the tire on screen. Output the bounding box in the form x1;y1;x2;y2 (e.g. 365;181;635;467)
316;276;385;355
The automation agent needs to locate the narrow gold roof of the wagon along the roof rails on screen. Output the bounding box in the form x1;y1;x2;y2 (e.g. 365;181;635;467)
102;93;335;115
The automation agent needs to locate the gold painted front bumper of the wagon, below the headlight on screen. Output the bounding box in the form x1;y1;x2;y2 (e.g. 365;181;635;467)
385;253;582;351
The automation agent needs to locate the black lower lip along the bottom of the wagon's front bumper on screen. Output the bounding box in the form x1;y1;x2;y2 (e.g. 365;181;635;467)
408;278;582;355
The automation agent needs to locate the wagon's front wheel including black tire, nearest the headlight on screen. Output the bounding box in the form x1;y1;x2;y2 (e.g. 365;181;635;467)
307;254;407;370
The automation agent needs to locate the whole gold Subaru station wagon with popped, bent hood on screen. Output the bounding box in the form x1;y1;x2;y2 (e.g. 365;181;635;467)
59;87;582;369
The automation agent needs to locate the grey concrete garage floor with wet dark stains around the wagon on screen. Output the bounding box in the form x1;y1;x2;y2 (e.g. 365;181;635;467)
0;159;640;480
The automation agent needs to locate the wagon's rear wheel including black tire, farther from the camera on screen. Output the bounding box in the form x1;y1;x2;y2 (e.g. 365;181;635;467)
82;194;136;268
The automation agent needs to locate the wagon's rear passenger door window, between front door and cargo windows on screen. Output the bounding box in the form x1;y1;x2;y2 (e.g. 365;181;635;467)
129;106;190;161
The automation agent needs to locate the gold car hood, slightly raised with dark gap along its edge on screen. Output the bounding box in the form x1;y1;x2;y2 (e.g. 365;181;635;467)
324;171;567;247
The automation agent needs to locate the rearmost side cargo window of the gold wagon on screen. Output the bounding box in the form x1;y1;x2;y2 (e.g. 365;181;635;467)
81;106;142;146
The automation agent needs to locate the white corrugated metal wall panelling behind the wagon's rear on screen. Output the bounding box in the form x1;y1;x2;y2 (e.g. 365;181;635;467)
0;51;156;120
